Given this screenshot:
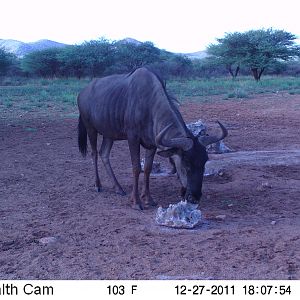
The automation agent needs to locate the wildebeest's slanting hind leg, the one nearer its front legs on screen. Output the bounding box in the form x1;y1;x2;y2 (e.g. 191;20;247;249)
100;137;126;196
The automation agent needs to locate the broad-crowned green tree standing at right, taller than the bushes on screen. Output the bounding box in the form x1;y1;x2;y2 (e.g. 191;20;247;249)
208;28;300;81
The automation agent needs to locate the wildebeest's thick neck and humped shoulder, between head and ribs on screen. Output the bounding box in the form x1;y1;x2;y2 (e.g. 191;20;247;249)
127;69;188;146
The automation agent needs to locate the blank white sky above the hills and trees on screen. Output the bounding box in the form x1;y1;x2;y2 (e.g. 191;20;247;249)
0;0;300;53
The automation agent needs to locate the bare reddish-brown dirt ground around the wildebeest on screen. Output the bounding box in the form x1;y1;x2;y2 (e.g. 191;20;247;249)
0;94;300;279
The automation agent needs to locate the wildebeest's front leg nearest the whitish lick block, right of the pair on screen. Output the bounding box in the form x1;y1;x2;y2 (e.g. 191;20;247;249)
142;149;157;206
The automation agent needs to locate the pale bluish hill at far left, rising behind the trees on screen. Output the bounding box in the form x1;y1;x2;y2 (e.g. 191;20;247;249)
0;39;66;57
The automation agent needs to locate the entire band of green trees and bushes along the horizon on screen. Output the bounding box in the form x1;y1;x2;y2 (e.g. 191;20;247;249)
4;29;300;80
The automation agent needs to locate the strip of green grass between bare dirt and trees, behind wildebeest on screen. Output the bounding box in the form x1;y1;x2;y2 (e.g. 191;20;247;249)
0;76;300;113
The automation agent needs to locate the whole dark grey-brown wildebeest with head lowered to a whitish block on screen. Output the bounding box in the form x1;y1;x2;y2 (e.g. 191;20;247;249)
77;68;227;209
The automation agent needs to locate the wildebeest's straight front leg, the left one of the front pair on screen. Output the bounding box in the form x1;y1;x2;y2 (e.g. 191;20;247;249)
128;137;143;209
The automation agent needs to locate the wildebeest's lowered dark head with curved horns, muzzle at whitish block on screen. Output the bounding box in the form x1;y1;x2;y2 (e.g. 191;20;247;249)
156;122;227;203
